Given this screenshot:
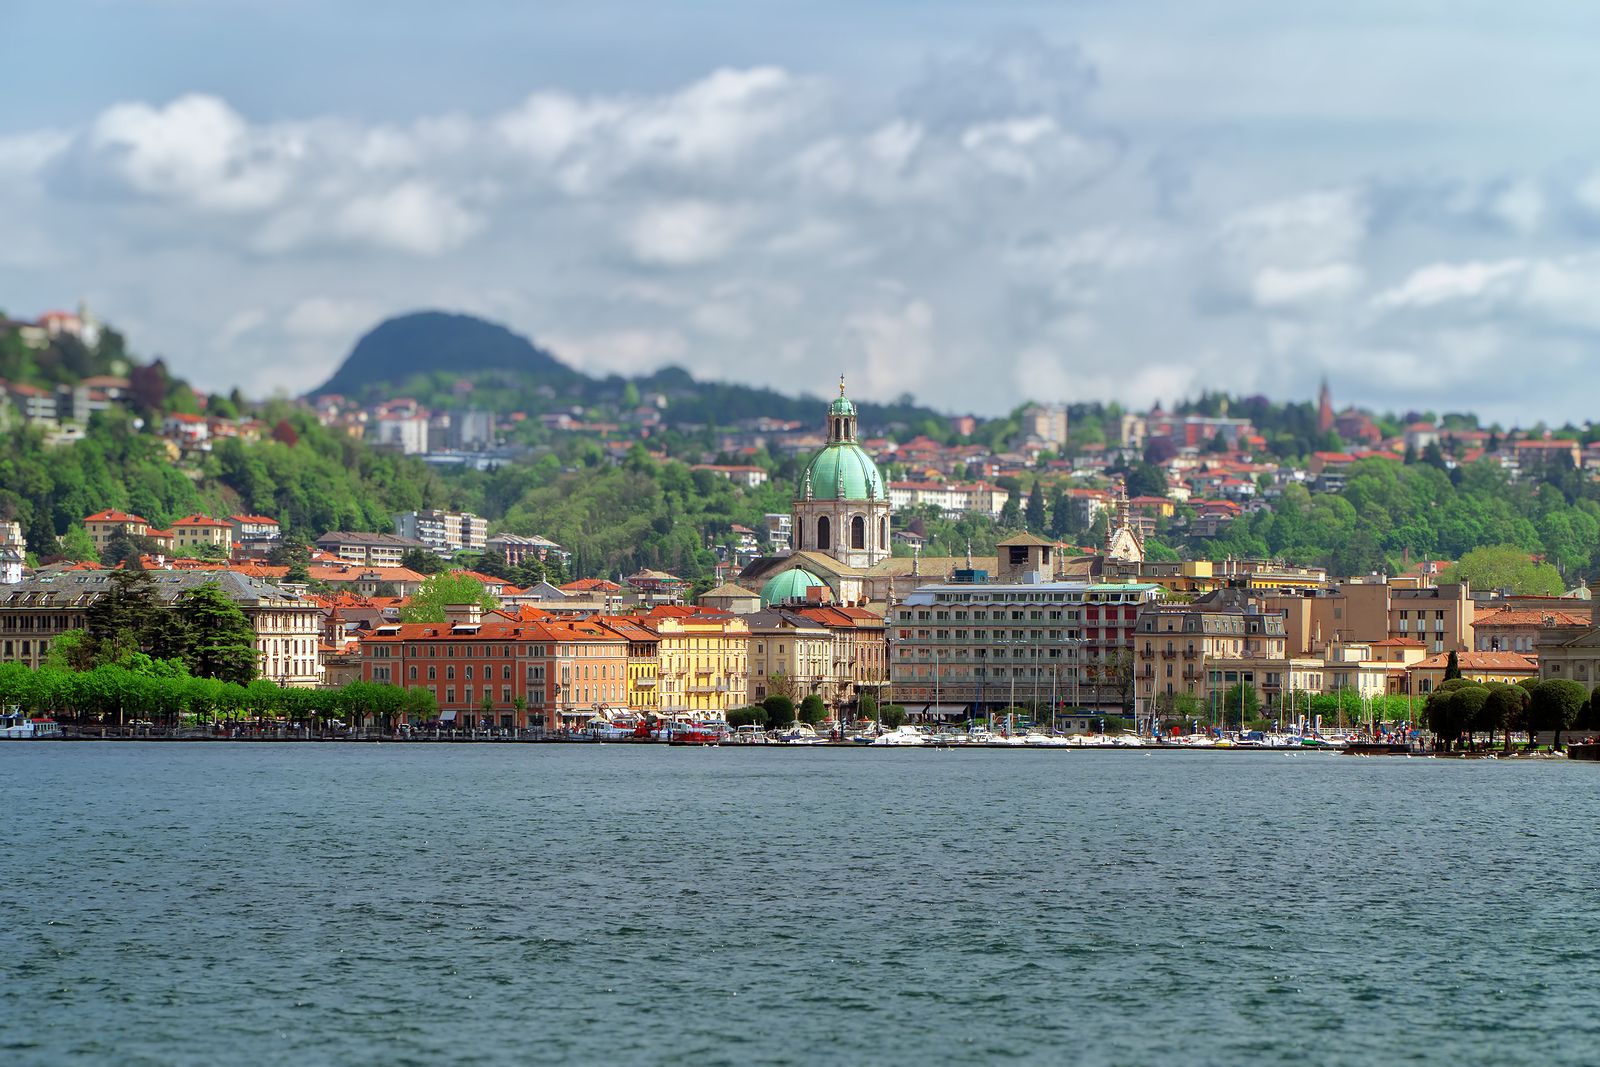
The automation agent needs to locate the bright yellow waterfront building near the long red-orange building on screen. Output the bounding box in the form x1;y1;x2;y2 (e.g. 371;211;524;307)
634;614;750;718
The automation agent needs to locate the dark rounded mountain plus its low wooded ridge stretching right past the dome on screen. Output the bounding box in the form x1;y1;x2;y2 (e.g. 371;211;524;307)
310;312;942;427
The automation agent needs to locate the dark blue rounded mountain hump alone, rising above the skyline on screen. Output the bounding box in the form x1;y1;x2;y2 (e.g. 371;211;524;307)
312;312;582;397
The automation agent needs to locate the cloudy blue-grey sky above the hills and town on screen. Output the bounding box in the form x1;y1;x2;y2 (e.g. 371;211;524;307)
0;0;1600;424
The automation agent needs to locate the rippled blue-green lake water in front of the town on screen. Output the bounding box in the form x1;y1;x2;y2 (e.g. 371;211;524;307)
0;742;1600;1065
